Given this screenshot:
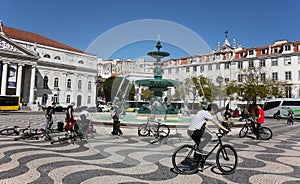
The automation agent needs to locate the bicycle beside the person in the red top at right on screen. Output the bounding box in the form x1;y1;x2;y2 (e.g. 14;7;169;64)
239;117;273;140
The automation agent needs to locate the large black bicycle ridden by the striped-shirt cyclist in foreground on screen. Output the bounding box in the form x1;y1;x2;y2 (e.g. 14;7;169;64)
172;132;238;174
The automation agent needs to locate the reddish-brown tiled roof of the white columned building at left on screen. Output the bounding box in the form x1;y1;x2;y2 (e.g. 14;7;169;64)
3;26;85;53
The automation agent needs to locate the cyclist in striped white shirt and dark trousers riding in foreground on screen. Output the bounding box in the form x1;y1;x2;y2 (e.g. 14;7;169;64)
187;104;229;156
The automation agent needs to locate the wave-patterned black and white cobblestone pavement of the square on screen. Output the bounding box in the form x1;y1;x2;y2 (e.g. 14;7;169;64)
0;114;300;184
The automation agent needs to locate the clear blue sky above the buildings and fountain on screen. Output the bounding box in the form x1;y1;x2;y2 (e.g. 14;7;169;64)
0;0;300;59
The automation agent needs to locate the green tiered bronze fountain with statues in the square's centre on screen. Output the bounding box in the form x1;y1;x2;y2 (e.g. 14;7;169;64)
135;40;181;119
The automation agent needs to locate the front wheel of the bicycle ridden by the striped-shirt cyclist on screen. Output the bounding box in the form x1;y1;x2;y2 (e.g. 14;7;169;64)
216;144;238;174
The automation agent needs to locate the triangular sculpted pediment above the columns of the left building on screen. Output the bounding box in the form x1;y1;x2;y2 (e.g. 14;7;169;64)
0;34;39;60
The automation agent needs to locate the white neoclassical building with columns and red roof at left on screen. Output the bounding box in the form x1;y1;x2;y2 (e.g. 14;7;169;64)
0;22;101;108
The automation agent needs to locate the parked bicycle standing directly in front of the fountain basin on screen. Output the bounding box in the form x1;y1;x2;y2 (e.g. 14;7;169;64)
138;118;170;137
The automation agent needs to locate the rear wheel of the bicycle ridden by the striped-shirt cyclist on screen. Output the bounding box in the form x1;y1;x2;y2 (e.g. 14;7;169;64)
172;144;201;174
